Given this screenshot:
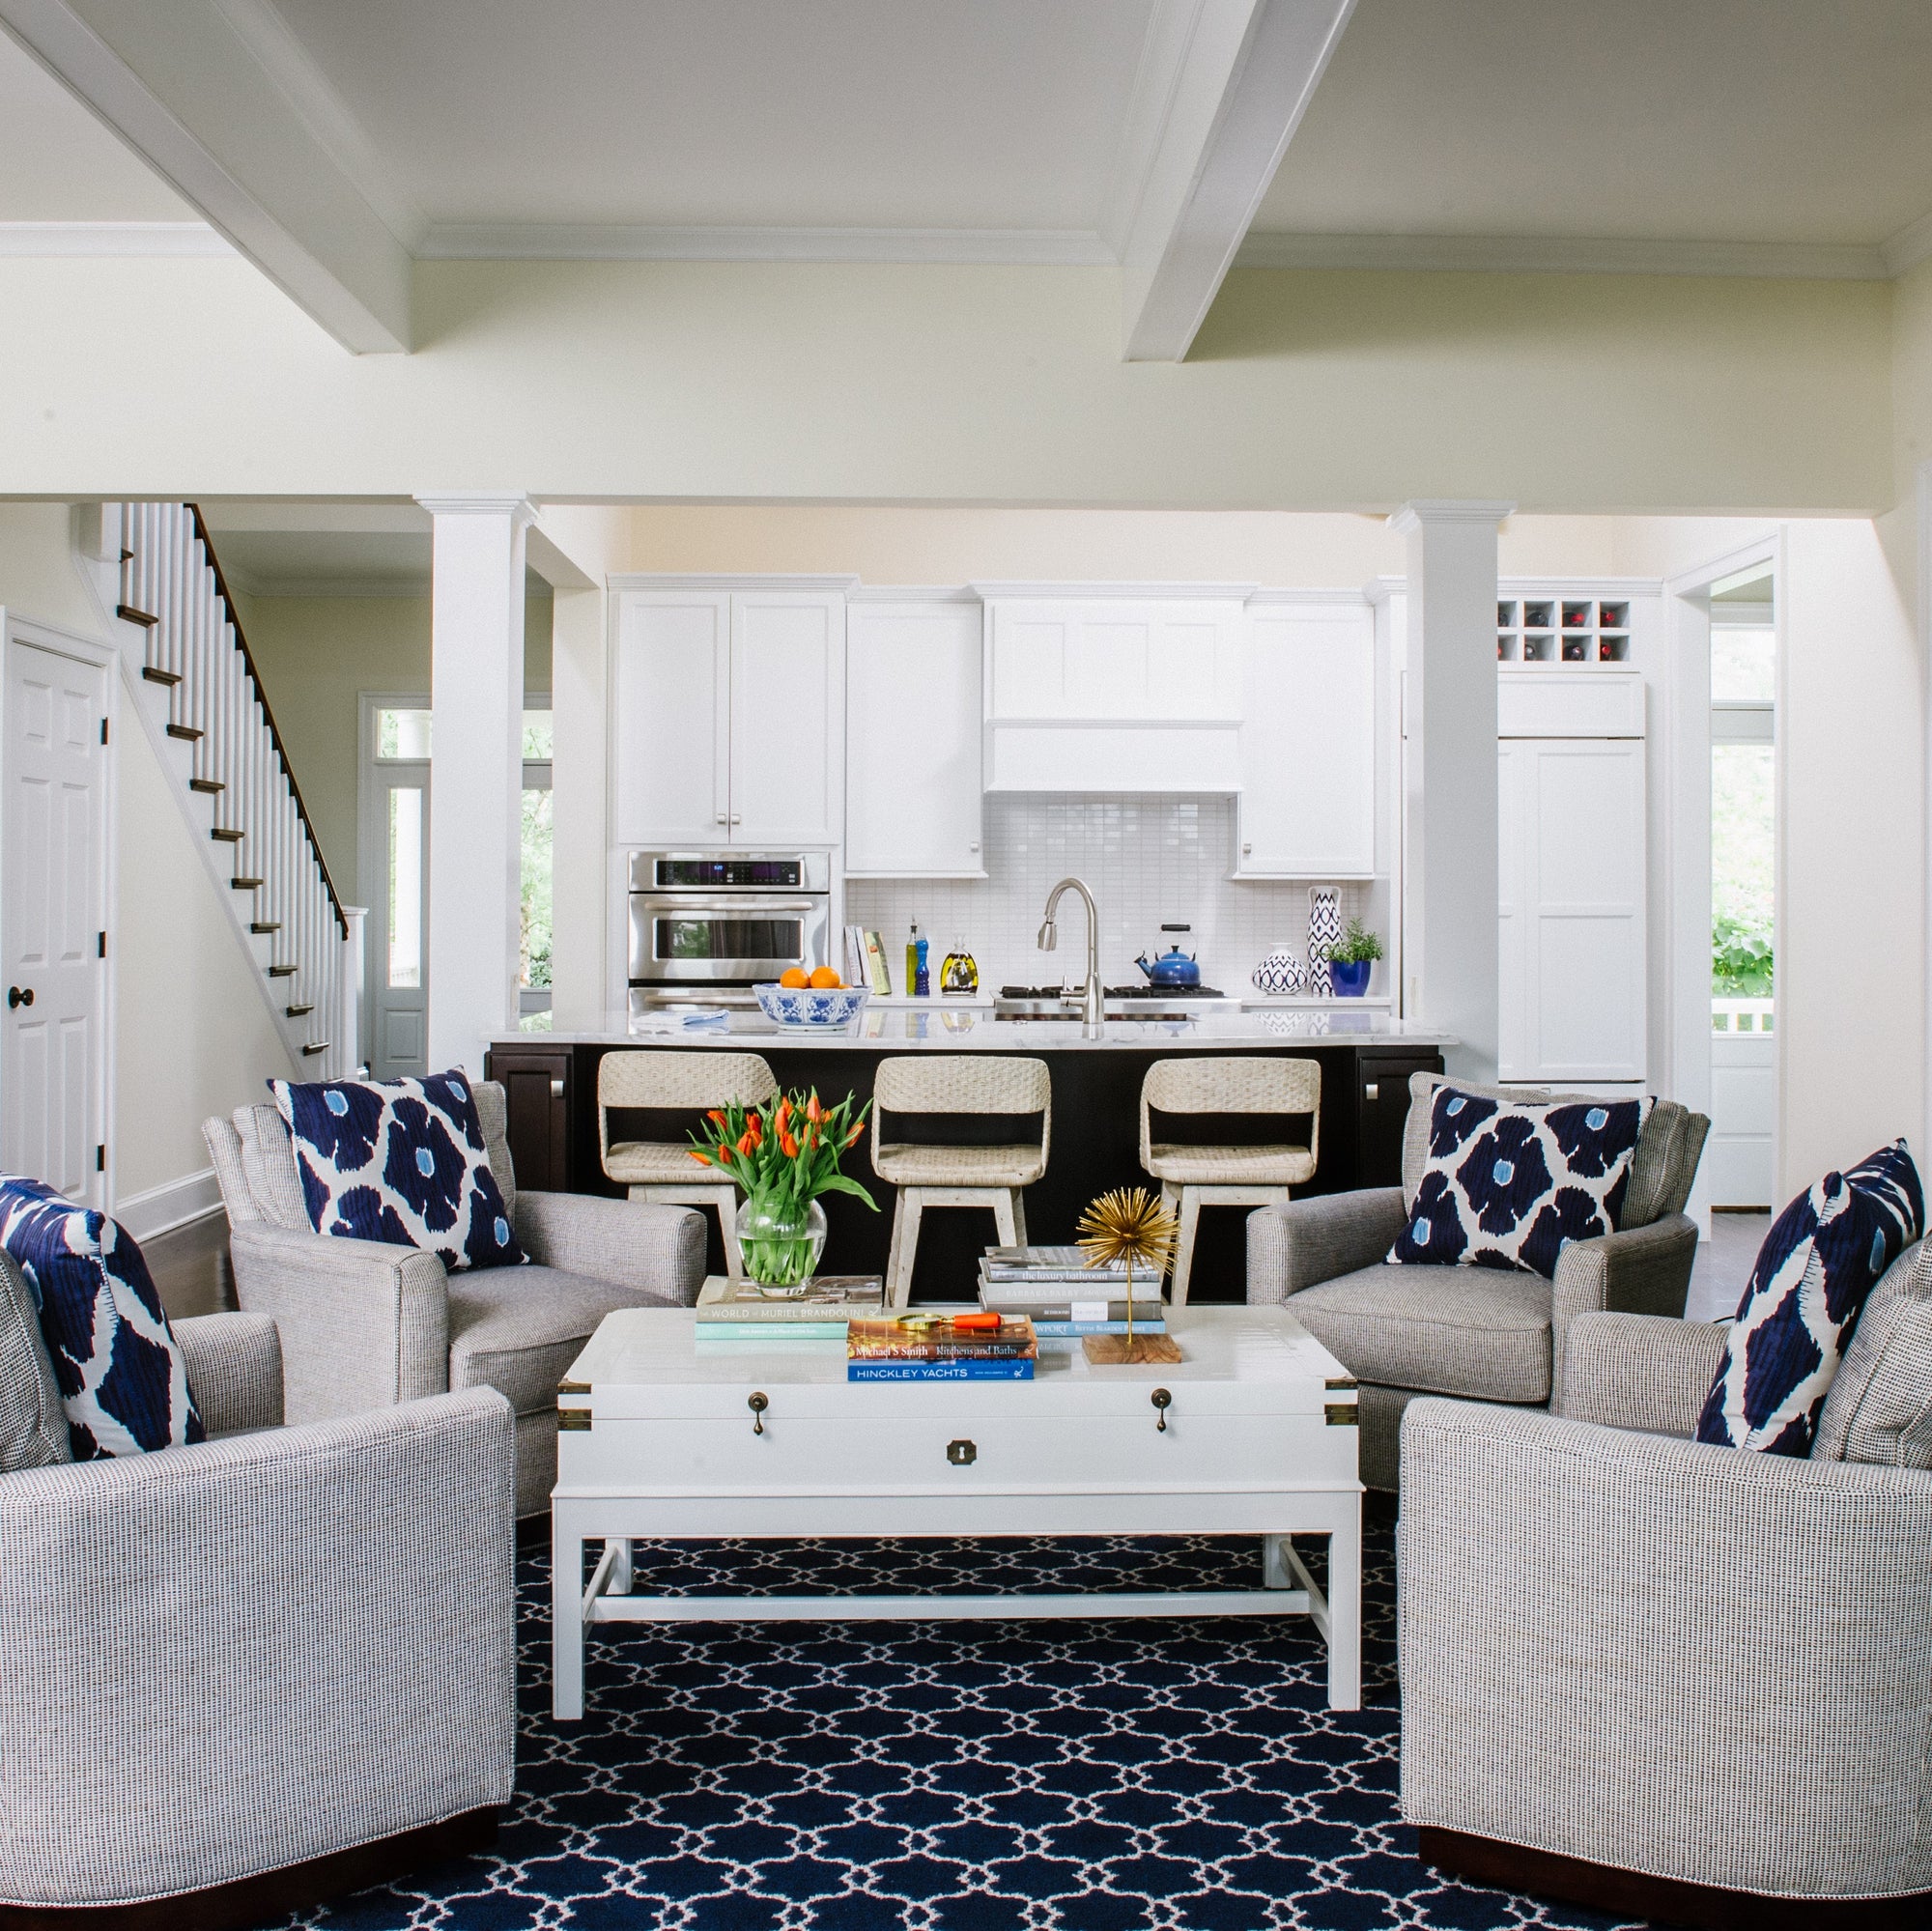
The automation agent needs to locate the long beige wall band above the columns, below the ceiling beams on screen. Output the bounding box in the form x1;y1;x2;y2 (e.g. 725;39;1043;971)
0;259;1893;514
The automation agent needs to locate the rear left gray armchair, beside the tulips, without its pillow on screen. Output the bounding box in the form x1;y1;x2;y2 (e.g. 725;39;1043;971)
201;1079;705;1516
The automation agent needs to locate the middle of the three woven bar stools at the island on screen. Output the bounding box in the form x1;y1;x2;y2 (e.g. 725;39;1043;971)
871;1052;1053;1307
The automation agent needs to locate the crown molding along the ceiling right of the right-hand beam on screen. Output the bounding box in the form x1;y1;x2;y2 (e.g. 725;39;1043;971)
1235;228;1886;282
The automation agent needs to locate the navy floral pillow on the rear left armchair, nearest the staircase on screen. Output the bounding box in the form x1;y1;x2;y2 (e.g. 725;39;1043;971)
269;1071;529;1272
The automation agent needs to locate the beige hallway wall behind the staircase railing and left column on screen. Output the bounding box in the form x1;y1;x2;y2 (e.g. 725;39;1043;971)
236;582;551;906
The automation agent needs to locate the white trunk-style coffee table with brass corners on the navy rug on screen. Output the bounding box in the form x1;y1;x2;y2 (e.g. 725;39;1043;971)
551;1307;1362;1718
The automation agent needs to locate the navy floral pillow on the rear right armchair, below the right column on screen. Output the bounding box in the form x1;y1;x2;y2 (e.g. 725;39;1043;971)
1389;1085;1656;1276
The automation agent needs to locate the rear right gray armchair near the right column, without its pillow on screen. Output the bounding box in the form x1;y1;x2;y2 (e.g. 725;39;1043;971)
1248;1073;1710;1489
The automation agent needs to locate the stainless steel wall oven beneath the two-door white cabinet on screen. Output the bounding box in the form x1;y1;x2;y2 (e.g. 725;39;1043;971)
630;852;831;1013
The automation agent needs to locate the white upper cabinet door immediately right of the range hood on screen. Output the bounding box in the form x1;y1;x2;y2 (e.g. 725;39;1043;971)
1235;607;1376;879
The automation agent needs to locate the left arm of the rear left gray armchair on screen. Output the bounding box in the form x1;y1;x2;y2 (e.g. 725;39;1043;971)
228;1222;450;1421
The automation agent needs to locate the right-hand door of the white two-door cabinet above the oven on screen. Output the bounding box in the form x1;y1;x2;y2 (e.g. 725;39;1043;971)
728;591;844;848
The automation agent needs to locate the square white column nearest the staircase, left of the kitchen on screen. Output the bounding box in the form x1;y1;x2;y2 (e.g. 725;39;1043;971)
417;495;537;1079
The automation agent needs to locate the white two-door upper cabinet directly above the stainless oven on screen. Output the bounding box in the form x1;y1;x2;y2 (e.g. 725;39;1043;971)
611;585;844;848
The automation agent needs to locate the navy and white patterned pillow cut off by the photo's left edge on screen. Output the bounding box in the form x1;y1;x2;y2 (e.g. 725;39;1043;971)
0;1174;207;1462
